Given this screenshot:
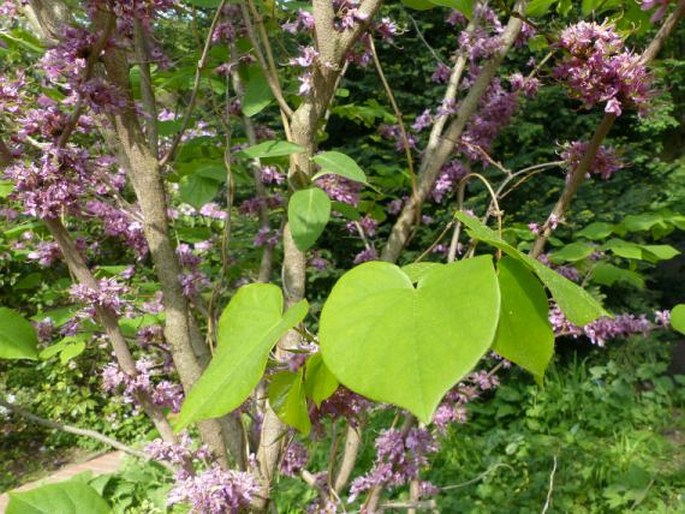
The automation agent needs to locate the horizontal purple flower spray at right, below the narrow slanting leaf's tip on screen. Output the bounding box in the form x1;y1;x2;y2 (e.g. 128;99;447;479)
549;305;655;347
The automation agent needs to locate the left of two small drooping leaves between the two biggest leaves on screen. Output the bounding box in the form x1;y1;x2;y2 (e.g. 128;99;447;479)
268;369;312;437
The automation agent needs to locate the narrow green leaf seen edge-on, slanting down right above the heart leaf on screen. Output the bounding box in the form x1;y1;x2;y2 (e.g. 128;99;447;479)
455;211;609;326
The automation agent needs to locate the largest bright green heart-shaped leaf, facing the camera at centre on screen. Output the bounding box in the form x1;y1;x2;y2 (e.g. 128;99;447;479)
319;256;499;423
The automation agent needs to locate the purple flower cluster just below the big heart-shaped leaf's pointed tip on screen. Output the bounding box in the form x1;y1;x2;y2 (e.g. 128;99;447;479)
349;427;438;502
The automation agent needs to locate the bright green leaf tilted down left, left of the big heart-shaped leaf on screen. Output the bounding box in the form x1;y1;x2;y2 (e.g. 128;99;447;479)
175;284;308;430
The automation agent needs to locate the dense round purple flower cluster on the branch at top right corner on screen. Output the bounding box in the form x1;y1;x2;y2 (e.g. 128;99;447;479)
554;21;652;116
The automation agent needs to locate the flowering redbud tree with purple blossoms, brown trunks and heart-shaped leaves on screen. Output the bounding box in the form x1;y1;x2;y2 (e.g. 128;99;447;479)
0;0;685;513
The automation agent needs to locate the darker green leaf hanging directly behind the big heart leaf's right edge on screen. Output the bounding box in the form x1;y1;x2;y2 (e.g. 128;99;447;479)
492;257;554;383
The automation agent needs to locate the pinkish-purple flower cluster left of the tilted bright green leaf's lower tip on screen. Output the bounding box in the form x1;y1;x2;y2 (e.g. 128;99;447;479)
102;358;183;412
